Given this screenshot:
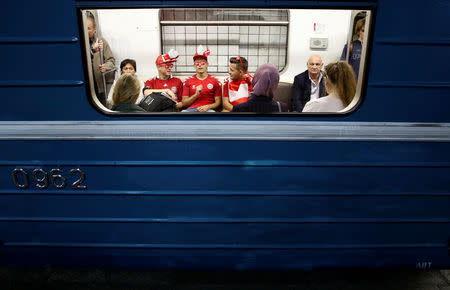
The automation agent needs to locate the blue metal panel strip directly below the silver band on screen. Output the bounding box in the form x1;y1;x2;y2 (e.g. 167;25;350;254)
0;140;450;168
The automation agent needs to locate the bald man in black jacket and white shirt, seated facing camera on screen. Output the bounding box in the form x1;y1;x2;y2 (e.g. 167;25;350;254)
291;55;326;112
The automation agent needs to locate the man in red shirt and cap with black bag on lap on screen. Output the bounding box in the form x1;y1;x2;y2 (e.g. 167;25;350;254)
143;49;183;110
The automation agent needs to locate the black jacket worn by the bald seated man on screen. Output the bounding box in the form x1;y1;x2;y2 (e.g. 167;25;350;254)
291;70;326;112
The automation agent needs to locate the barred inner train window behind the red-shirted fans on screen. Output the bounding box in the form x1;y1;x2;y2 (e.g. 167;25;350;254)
160;9;289;73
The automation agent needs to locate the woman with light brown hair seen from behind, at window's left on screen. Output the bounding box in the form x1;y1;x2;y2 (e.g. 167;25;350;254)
111;73;145;113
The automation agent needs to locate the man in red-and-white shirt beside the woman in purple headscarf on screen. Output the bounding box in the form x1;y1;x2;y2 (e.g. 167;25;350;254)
222;56;253;112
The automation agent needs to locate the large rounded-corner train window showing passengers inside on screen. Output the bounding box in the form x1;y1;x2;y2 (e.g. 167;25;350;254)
80;8;371;117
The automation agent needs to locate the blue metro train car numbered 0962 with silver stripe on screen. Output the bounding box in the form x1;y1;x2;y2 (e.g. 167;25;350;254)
0;0;450;269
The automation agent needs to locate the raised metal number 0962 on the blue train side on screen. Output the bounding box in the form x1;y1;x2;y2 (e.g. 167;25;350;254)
12;168;87;189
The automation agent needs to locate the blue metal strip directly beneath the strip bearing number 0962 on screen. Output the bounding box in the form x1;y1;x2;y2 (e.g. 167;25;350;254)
0;195;450;220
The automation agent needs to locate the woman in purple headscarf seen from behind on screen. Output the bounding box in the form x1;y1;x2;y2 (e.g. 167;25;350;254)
233;64;288;113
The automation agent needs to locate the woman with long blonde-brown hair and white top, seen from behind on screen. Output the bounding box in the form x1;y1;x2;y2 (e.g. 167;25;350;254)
303;60;356;112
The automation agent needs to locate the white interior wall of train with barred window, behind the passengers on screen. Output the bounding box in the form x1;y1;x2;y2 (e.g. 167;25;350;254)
80;8;371;114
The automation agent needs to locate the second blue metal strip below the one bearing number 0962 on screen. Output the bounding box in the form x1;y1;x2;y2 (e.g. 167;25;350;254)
0;220;450;245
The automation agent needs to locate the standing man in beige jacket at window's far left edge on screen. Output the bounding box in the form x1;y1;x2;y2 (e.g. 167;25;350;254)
87;11;116;107
